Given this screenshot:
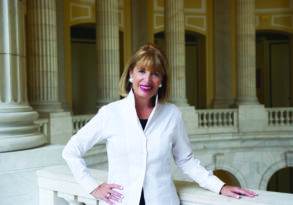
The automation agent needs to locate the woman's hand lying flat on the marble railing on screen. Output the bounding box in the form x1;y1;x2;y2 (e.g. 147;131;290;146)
220;185;257;199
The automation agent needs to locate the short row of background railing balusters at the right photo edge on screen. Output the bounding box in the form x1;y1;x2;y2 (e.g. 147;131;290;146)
267;108;293;126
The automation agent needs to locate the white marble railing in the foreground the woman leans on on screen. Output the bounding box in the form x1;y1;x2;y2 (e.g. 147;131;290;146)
37;166;293;205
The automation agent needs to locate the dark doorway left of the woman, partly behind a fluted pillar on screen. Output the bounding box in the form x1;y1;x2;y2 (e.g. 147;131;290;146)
71;24;124;115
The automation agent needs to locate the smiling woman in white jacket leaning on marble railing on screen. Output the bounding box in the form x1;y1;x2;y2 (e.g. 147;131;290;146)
63;44;255;205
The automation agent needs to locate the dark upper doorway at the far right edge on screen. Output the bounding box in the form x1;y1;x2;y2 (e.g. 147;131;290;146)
256;31;293;107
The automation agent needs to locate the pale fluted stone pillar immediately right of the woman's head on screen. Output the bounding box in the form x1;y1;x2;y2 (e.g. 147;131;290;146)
165;0;187;106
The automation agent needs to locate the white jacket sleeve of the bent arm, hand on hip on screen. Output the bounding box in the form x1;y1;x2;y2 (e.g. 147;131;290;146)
62;107;107;193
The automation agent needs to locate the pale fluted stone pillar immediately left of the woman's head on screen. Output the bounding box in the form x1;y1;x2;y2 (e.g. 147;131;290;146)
96;0;120;108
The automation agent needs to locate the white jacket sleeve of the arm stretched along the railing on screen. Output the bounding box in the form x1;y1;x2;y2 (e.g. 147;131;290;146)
172;111;225;193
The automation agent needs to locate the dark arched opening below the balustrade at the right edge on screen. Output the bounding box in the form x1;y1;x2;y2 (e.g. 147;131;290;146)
267;167;293;193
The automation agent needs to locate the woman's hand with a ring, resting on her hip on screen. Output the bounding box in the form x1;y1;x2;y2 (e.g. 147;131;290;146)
90;183;123;205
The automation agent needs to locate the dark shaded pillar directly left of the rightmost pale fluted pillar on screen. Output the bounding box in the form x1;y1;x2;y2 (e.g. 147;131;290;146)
213;0;234;108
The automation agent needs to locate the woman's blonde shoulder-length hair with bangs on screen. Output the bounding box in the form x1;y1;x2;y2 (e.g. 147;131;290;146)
119;43;169;102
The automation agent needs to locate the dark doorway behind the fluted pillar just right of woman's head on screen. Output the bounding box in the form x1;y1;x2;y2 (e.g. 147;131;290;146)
154;31;206;108
